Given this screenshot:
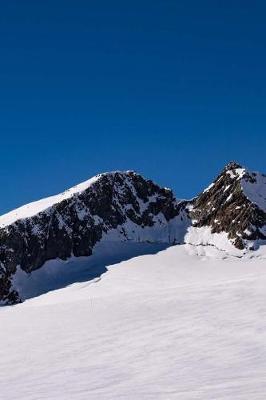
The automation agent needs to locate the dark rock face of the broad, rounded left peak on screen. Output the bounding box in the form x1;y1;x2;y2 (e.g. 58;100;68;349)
0;172;187;303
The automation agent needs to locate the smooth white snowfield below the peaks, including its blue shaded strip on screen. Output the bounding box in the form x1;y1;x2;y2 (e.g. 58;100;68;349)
0;243;266;400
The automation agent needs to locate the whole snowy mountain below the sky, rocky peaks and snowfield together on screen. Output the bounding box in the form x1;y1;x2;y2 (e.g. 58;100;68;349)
0;163;266;400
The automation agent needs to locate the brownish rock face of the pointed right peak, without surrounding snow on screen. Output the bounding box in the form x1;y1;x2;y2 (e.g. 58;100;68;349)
190;162;266;249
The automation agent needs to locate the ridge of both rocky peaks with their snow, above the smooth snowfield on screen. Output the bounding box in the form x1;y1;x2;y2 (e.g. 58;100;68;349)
0;163;266;303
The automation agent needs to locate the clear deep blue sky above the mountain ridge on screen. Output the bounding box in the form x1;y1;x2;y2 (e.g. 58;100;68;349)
0;0;266;213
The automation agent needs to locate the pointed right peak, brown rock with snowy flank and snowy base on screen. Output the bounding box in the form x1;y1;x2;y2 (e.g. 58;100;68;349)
186;162;266;254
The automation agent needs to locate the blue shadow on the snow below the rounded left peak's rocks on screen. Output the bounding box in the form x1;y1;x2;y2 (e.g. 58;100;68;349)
13;241;169;300
